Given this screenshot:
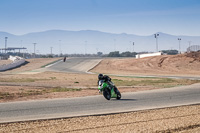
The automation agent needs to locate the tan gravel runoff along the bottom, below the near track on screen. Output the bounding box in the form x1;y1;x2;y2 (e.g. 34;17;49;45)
0;104;200;133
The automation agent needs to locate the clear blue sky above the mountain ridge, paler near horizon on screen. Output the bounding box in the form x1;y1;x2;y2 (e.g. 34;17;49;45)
0;0;200;36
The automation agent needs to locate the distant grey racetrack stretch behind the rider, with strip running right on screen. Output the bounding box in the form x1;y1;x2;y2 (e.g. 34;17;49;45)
46;57;200;80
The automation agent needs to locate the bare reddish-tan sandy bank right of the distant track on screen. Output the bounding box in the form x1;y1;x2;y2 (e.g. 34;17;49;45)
92;52;200;76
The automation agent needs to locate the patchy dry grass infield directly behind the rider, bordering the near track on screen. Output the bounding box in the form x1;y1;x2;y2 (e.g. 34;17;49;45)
0;72;199;102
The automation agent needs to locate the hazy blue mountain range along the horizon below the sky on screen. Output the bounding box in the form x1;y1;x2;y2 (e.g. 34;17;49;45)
0;30;200;54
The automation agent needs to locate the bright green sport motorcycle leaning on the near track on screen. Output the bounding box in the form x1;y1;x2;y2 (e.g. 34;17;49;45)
98;81;121;100
